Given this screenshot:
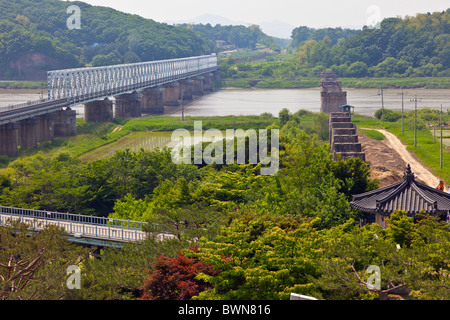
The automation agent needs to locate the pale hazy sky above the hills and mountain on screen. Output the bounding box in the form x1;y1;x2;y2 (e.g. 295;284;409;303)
82;0;450;28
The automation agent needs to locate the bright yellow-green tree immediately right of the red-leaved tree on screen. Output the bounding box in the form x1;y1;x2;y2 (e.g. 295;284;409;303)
192;212;318;300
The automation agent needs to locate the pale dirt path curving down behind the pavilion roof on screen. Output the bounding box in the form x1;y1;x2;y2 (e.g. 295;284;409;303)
377;129;440;187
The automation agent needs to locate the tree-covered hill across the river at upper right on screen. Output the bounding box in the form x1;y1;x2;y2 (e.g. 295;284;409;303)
293;9;450;77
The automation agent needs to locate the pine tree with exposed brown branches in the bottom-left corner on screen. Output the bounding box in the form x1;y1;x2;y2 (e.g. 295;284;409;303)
0;222;90;300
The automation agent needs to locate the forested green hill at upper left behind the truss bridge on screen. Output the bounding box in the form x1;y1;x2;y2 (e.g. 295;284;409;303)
0;0;215;80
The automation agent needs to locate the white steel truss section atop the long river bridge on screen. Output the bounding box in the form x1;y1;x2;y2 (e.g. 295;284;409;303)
48;55;218;105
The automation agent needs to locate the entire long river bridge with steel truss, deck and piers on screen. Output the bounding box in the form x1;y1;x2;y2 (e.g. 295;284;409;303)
0;55;218;156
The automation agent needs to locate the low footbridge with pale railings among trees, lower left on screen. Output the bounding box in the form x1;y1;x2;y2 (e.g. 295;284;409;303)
0;206;173;246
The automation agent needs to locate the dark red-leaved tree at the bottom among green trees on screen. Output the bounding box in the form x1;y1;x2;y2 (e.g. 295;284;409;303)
141;249;219;300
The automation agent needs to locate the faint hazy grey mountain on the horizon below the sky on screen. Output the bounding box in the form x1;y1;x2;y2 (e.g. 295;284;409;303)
166;14;294;39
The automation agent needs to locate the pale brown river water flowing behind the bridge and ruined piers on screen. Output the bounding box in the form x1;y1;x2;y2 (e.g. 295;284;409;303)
0;88;450;116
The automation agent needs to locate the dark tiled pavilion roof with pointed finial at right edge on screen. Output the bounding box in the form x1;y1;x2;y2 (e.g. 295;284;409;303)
350;164;450;215
